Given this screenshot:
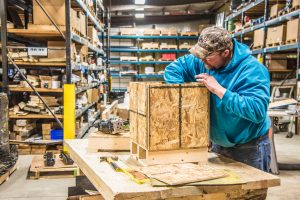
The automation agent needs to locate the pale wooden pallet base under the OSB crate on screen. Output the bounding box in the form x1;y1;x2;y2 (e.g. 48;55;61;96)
130;141;208;166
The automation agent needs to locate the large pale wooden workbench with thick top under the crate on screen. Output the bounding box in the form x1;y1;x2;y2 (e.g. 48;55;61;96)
65;139;280;200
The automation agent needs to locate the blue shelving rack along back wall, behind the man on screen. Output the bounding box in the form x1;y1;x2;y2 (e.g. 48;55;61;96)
106;35;198;92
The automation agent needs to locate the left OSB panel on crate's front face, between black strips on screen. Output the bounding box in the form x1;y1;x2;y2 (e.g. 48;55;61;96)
149;88;179;150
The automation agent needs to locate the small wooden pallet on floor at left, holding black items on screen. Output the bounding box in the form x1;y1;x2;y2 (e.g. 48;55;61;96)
28;154;79;179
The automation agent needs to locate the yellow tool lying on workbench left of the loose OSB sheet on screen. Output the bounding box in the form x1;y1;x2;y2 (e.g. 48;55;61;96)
100;156;150;184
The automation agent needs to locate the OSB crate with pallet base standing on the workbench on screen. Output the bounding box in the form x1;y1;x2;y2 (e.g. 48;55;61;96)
129;82;209;165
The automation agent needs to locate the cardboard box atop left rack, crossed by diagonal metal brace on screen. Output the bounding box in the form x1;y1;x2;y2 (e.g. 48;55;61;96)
32;0;66;26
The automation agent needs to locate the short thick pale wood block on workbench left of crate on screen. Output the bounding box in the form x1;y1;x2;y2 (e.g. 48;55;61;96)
88;131;130;152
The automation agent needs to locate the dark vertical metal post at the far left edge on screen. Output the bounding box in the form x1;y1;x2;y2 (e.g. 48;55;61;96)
0;0;8;93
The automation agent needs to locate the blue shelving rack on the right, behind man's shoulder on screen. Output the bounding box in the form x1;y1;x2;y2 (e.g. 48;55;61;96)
224;0;300;91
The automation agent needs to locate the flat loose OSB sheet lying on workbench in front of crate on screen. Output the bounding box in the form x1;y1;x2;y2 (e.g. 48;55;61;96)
140;163;227;185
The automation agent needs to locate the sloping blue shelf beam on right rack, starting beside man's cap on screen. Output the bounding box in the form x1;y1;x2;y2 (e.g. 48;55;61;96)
232;10;300;37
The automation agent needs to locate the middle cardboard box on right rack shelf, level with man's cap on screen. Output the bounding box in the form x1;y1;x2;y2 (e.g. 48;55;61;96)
267;25;286;45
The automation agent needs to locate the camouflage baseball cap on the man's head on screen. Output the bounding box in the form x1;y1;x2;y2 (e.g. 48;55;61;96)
190;26;232;59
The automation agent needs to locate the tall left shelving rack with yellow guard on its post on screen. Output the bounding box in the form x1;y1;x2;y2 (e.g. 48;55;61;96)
0;0;110;144
